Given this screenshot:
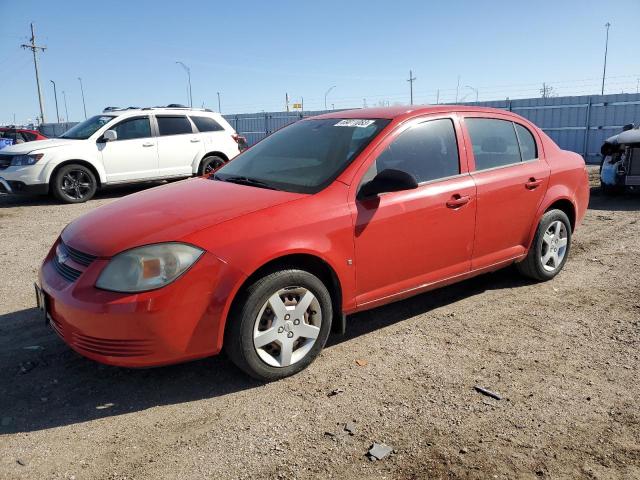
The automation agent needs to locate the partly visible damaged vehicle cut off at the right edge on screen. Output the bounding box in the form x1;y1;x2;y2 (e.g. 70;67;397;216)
600;124;640;195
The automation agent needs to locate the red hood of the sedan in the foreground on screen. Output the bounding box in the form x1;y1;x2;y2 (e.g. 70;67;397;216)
62;178;305;257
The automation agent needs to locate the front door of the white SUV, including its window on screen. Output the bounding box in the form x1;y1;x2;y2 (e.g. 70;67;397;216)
98;115;159;183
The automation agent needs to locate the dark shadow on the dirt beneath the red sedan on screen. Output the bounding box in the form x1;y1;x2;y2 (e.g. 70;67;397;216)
0;269;528;434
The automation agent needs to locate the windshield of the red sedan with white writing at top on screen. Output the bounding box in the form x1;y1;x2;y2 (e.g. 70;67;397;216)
213;118;389;193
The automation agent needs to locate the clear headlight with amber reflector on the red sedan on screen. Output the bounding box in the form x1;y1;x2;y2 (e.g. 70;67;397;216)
96;243;203;293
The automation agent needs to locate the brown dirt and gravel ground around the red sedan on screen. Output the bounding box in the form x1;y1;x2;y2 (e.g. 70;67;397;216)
0;170;640;480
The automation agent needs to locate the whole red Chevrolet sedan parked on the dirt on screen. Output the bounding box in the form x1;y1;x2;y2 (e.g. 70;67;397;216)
36;106;589;380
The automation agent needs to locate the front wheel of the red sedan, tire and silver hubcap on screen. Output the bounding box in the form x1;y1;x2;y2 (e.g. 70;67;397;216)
224;269;333;381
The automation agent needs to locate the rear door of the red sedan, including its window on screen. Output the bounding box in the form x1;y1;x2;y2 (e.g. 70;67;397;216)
463;114;550;270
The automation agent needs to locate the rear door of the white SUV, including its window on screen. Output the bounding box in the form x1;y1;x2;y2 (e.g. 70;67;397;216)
155;115;204;177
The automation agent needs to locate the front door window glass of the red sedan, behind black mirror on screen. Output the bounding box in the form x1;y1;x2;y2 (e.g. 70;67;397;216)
364;119;460;183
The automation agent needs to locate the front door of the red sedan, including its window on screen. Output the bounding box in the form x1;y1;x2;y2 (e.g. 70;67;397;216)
354;117;476;306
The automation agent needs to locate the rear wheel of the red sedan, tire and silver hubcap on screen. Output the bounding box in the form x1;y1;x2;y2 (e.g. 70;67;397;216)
516;210;571;281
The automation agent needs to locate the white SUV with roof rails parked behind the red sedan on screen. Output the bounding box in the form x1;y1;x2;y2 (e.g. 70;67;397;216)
0;108;246;203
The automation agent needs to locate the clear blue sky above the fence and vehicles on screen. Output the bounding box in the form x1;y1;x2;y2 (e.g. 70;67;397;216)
0;0;640;123
